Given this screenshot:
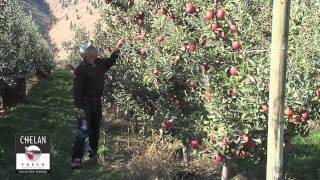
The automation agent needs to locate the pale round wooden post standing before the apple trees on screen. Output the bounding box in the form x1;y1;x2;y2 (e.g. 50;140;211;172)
267;0;290;180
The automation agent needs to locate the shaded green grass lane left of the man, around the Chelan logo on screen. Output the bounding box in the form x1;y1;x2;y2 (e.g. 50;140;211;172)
0;70;117;180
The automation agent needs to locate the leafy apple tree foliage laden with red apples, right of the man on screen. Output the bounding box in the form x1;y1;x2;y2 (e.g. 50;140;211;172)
68;0;320;167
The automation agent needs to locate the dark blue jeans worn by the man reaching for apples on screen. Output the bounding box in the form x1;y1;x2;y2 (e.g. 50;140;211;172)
72;98;102;160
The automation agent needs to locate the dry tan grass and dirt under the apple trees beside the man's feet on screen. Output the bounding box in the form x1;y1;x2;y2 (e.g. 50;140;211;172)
99;107;221;180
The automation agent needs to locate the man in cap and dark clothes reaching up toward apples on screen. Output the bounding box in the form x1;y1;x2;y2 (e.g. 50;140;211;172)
71;39;124;168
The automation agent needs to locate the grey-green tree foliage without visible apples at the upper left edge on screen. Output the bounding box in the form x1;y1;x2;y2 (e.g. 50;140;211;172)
0;0;54;85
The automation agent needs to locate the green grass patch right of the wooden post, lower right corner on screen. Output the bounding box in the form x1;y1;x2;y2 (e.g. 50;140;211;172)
284;129;320;180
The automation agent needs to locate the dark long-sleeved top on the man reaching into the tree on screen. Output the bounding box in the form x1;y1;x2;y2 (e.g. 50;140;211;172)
73;51;119;108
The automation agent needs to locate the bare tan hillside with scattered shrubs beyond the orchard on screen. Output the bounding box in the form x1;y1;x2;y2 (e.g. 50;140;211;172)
22;0;99;61
